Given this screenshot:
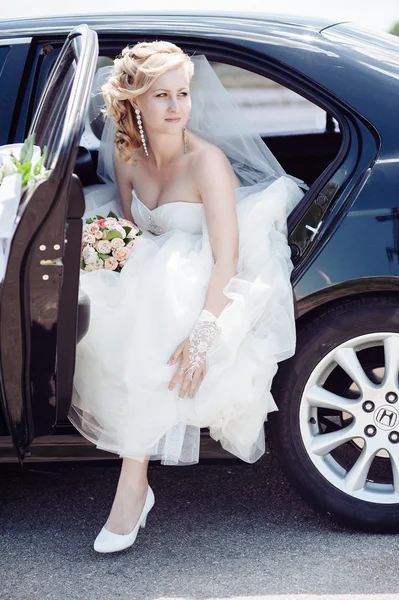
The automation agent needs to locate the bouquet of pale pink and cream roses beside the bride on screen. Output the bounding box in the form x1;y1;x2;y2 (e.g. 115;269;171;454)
80;212;143;273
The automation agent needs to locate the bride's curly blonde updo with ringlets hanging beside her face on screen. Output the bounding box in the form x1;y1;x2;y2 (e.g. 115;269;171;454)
101;41;194;165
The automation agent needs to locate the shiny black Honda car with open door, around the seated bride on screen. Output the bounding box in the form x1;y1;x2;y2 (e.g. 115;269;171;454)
0;13;399;531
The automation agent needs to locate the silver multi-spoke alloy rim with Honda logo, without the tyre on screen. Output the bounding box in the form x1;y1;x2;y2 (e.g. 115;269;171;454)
299;332;399;504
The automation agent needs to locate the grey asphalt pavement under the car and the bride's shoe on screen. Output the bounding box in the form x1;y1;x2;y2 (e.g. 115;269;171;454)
0;454;399;600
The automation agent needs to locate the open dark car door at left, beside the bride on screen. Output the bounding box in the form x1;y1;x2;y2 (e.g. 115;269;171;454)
0;25;98;460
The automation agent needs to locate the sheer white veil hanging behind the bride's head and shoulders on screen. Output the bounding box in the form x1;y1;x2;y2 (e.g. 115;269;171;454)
86;55;307;218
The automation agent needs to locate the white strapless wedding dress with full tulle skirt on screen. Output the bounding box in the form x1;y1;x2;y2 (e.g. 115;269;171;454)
69;176;303;465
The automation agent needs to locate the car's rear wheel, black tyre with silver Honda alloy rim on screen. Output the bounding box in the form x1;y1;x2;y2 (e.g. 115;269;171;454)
268;295;399;532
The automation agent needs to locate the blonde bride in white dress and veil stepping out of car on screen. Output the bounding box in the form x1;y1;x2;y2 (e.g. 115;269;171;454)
69;41;303;552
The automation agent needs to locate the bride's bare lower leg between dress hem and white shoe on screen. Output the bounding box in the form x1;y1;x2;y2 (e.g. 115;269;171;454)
105;458;149;534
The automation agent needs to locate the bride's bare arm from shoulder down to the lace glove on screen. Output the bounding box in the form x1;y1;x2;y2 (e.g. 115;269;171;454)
194;147;238;317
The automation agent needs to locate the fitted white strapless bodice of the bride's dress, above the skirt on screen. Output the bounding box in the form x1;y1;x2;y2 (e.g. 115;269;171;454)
132;190;204;235
